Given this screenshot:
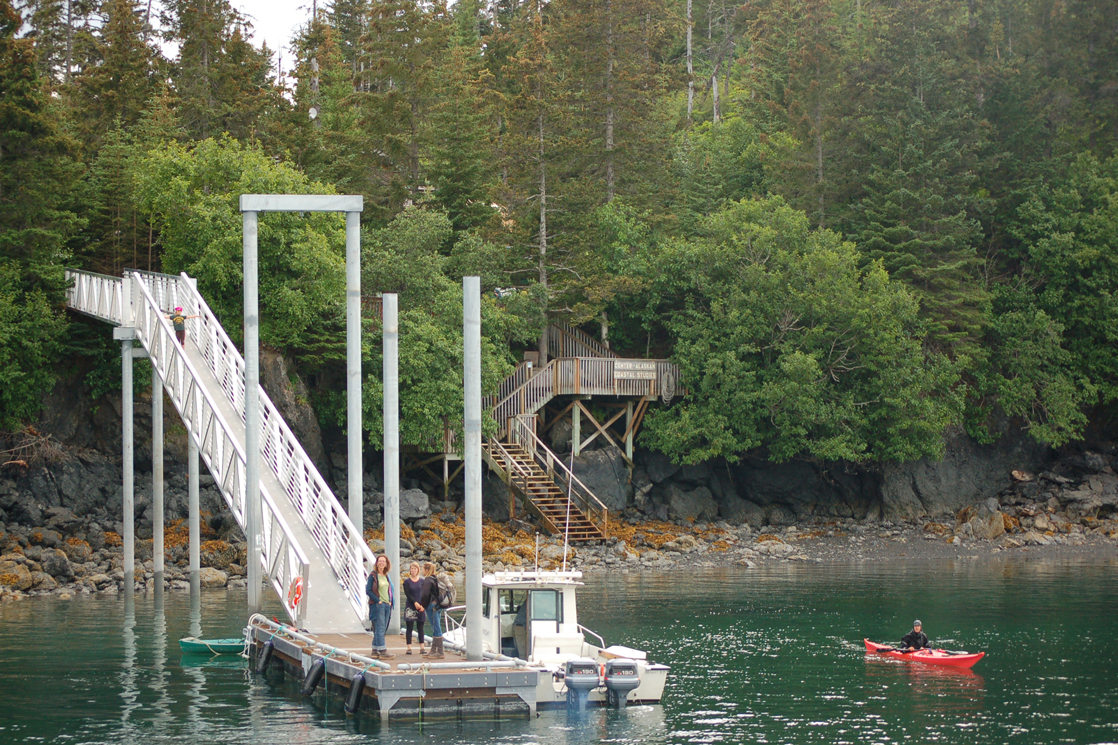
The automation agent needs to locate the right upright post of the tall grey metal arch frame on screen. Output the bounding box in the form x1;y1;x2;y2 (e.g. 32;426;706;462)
345;213;362;534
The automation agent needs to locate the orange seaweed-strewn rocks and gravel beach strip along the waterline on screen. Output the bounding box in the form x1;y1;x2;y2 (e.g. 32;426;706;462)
0;481;1118;601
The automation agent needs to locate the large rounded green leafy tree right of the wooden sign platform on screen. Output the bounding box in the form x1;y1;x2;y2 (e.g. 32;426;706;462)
645;199;961;463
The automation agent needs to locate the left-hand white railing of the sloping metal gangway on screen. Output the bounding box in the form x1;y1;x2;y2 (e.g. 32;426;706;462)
124;273;311;625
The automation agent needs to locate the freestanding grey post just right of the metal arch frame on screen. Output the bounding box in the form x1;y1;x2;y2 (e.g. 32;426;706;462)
381;293;402;634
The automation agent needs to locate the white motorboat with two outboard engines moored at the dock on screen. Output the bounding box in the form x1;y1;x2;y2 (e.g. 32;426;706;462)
445;572;669;707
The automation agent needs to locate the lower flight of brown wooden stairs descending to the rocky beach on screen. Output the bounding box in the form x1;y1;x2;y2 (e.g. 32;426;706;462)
482;422;609;543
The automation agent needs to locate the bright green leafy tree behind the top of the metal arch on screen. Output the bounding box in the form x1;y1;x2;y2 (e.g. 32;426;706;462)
138;139;345;348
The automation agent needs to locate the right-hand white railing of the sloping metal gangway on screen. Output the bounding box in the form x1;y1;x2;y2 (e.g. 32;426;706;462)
180;273;376;619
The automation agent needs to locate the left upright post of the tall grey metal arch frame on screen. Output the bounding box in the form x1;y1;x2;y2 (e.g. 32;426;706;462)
241;213;263;615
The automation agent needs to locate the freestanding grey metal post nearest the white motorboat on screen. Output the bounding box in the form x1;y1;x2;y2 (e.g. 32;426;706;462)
462;276;482;661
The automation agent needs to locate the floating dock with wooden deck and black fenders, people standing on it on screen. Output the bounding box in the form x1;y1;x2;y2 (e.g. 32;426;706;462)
249;616;547;720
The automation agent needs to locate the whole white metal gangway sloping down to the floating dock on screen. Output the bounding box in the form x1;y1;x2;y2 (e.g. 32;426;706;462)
66;270;373;633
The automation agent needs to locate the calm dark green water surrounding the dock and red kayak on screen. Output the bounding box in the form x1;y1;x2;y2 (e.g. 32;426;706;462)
0;559;1118;745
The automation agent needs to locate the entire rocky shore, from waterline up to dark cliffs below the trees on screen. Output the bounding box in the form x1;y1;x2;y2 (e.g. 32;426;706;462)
0;431;1118;601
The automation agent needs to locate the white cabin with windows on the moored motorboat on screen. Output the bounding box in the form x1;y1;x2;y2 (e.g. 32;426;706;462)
482;572;586;664
